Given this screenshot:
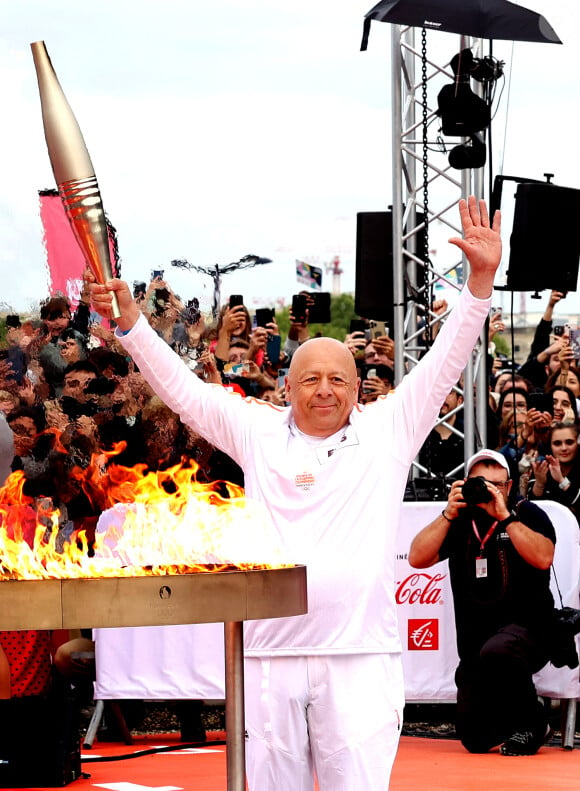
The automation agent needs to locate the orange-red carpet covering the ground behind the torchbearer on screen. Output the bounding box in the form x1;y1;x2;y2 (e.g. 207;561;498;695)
17;734;580;791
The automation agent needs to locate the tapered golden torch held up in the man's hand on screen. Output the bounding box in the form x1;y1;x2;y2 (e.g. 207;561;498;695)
30;41;121;318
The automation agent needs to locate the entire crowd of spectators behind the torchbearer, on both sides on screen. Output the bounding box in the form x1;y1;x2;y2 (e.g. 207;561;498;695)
0;278;580;744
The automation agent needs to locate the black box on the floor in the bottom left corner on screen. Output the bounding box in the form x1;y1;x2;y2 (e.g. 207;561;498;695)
0;688;81;788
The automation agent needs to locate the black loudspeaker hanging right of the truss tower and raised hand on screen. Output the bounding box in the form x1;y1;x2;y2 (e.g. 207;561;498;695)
507;183;580;291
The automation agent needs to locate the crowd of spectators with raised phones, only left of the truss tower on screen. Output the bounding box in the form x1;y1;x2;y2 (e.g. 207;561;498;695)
0;277;394;708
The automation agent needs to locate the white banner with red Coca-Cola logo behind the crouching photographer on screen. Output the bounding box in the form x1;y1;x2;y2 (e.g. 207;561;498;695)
395;501;580;703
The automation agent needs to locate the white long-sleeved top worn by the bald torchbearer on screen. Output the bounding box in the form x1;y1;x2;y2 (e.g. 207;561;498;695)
118;288;491;656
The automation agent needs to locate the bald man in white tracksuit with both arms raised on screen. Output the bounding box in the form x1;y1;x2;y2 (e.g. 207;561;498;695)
87;198;501;791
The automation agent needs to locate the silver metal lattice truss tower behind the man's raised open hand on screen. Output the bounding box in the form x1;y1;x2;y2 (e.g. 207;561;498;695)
391;25;487;477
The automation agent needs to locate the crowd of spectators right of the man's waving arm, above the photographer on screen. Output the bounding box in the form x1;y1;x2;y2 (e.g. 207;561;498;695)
420;291;580;522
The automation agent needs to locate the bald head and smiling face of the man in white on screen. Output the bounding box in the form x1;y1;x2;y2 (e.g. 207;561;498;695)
286;338;359;437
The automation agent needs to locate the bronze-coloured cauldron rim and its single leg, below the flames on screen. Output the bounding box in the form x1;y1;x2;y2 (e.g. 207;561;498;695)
0;566;307;791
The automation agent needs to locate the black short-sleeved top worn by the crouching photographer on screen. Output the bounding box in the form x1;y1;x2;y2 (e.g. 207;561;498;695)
439;500;556;661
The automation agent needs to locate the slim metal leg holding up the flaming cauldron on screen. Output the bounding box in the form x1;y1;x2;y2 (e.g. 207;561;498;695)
224;621;246;791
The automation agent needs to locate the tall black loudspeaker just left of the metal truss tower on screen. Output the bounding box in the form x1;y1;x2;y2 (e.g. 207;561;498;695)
354;211;393;330
